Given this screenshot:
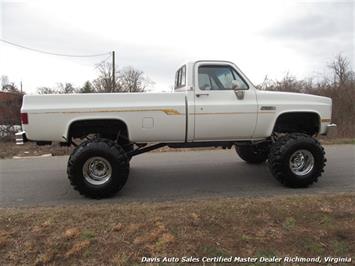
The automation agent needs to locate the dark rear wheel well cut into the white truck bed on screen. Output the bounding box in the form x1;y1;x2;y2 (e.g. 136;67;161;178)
68;119;129;144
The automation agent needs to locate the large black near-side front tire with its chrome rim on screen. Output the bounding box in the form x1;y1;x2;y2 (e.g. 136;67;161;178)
268;133;326;188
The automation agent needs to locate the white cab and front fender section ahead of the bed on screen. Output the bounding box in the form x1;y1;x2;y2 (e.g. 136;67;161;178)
174;60;331;141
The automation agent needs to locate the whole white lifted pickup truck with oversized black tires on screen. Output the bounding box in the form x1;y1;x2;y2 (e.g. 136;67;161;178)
16;61;335;198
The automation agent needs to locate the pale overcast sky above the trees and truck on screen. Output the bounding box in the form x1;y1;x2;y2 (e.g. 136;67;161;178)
0;0;355;94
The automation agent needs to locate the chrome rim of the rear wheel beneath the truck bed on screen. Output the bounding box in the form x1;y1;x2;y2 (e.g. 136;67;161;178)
83;157;112;186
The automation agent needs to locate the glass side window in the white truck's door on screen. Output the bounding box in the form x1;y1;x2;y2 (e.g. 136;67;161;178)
198;65;249;90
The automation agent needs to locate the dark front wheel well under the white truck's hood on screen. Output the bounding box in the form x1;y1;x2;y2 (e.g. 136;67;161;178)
273;112;320;136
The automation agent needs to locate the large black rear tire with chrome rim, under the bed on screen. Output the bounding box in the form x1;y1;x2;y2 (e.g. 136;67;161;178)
67;138;129;199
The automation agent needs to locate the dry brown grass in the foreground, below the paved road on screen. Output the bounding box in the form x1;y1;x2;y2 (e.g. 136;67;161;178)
0;193;355;265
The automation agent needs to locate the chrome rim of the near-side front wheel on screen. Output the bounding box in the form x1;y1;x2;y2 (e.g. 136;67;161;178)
289;150;314;176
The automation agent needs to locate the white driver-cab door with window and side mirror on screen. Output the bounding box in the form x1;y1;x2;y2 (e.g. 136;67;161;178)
194;63;257;141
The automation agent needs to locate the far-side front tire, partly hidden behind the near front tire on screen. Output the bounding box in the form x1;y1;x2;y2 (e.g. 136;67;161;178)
235;143;270;164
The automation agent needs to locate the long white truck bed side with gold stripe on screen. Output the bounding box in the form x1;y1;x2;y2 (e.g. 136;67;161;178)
21;92;186;142
